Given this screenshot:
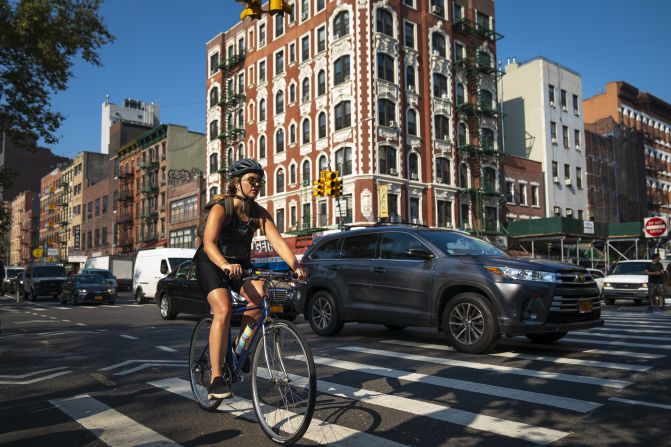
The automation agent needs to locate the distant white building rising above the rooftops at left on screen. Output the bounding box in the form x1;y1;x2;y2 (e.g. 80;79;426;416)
100;96;161;154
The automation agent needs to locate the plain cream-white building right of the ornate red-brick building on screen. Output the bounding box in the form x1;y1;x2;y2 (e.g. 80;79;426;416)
500;57;589;220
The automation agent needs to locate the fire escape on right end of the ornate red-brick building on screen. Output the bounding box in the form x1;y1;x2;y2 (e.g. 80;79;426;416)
454;11;503;235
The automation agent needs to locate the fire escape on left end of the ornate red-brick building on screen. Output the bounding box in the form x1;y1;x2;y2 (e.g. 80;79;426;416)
219;49;246;176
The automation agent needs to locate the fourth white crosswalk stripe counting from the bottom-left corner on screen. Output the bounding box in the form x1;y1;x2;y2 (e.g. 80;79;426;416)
314;356;601;413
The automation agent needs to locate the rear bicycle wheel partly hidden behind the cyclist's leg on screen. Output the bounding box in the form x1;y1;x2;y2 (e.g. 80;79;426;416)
189;317;222;411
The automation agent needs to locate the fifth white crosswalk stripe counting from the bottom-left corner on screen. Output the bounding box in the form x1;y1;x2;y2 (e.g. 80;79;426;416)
338;346;632;388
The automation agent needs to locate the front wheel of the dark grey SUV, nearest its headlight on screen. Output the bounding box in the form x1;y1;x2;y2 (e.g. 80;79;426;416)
443;292;501;354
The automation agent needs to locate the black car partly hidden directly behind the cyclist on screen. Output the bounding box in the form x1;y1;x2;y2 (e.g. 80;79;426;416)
156;260;298;322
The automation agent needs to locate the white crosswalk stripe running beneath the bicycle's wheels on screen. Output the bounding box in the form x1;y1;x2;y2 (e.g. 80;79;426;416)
149;378;403;447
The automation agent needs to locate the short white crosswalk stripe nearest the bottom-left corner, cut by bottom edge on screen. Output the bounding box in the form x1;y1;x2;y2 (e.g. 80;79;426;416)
49;394;180;447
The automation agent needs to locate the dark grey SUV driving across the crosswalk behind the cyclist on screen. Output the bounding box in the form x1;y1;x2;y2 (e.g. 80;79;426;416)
298;225;603;353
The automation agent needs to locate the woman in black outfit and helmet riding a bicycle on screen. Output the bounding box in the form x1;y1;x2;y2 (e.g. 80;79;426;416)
194;158;307;399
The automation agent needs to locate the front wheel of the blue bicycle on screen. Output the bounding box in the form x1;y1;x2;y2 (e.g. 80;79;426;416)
251;320;317;445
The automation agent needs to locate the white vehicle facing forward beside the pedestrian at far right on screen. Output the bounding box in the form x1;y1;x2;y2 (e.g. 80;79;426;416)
601;259;671;305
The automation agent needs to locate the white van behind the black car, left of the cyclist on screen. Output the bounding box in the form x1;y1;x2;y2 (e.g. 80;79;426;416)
133;248;196;304
